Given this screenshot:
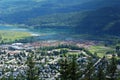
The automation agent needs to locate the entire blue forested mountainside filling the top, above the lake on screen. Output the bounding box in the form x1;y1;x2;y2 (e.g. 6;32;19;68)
0;0;120;35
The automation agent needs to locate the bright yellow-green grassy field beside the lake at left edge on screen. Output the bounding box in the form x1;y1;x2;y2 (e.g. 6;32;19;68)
0;31;31;43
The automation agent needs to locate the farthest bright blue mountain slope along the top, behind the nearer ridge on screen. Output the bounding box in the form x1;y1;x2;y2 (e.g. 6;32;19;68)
0;0;120;24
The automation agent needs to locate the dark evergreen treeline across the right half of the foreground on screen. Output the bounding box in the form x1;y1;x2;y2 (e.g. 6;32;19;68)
58;55;120;80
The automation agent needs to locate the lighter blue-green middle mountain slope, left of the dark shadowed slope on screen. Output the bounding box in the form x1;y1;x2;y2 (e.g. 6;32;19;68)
25;12;87;27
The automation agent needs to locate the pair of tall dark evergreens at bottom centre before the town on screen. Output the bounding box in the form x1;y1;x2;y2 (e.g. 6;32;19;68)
59;54;82;80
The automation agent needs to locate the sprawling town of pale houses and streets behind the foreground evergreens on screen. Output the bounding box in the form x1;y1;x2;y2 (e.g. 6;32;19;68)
0;41;120;80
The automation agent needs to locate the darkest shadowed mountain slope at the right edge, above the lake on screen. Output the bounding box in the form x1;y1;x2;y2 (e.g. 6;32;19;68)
78;7;120;35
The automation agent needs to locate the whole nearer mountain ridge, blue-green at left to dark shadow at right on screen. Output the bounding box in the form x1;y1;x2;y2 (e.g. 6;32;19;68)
25;7;120;35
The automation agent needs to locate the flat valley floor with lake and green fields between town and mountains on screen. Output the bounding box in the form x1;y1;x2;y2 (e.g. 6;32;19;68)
0;25;119;57
